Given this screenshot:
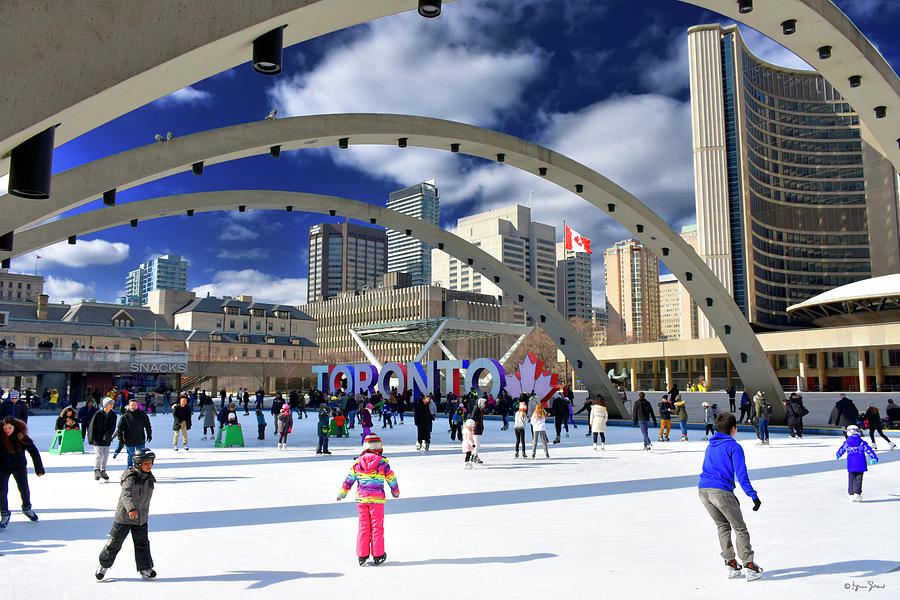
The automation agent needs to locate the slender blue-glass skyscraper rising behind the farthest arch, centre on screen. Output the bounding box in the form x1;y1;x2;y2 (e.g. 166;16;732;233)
387;179;441;285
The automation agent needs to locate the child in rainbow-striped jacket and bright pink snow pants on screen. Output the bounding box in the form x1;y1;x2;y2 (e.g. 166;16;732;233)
337;435;400;566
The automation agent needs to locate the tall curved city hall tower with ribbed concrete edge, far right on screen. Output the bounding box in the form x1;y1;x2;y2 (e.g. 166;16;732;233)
688;25;900;330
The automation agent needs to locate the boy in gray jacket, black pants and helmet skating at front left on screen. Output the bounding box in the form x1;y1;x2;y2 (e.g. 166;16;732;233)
94;448;156;581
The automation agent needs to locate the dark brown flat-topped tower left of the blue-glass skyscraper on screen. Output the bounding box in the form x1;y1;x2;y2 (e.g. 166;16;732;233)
306;223;387;302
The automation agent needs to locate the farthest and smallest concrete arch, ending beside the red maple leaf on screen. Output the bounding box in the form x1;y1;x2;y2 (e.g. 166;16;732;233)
5;190;628;418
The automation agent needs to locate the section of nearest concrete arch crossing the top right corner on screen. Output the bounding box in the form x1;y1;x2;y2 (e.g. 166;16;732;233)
680;0;900;171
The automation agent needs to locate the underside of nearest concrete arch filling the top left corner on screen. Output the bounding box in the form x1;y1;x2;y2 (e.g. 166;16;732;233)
0;0;454;175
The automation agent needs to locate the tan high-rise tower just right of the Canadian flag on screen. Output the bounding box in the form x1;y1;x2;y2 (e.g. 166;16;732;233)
603;240;659;344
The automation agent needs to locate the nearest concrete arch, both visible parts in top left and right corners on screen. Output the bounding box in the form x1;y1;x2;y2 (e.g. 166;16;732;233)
0;0;900;174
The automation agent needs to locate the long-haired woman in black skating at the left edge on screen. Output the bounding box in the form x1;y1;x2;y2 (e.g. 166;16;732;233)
0;417;44;529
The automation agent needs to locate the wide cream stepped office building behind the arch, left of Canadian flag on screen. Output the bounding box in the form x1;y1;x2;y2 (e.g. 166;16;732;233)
431;205;556;323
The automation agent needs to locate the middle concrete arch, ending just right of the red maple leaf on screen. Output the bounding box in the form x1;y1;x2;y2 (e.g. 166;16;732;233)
0;114;783;410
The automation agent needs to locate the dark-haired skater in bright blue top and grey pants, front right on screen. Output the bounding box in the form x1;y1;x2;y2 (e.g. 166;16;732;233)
697;413;763;581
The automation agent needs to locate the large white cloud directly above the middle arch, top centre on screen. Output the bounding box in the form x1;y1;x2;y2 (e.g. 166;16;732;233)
269;6;547;125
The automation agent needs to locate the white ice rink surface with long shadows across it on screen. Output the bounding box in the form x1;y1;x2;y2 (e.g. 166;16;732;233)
0;411;900;600
